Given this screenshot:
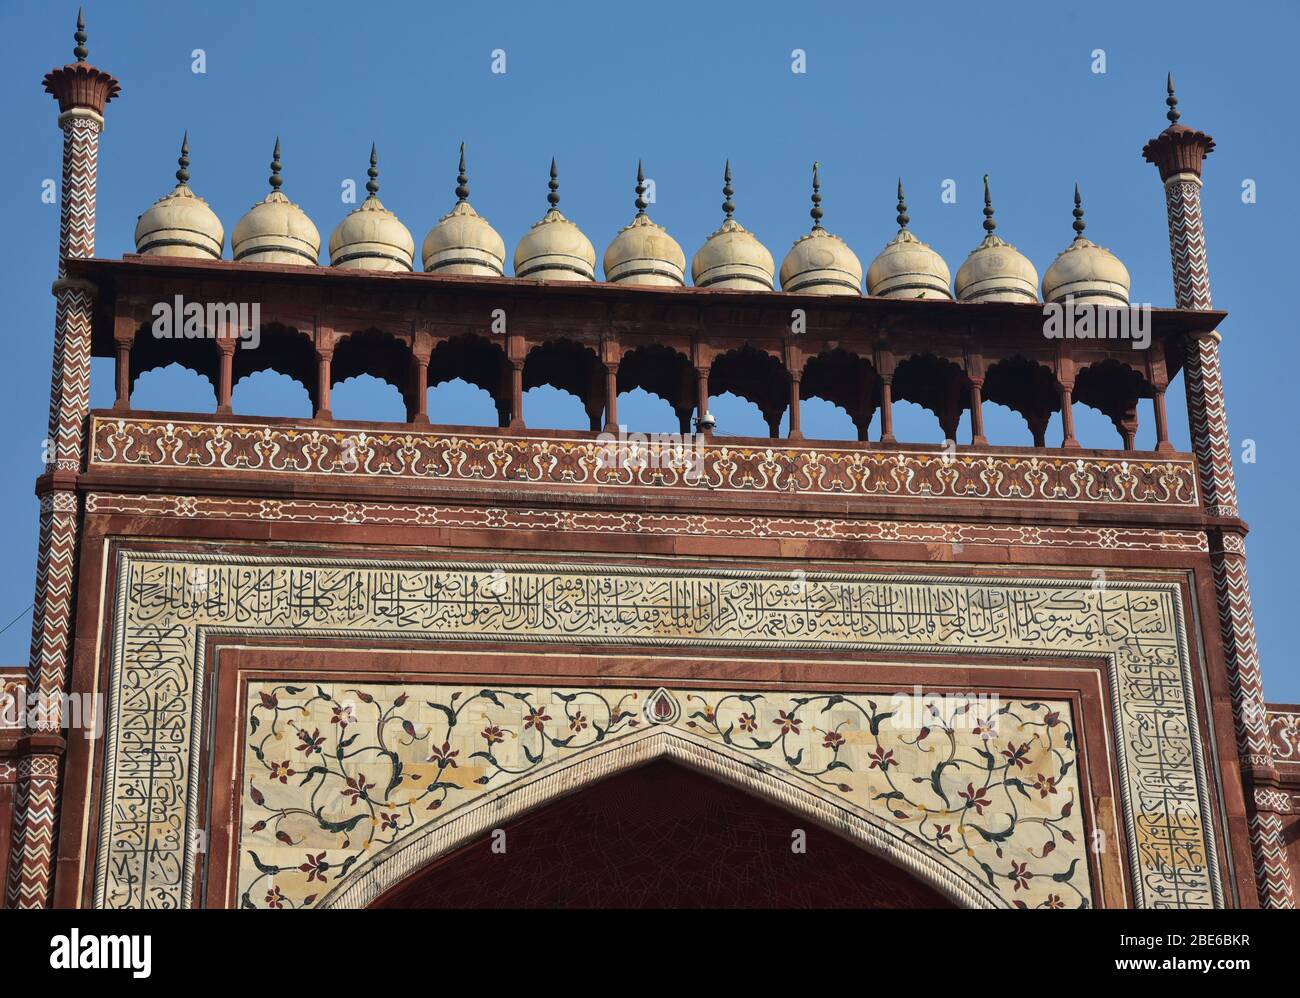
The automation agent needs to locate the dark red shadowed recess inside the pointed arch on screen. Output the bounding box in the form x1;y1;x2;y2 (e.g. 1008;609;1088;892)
371;759;953;908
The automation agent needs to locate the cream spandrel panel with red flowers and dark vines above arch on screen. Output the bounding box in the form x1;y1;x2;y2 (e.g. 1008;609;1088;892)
239;684;1091;908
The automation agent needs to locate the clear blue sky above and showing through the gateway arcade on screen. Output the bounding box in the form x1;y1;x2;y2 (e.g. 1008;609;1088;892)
0;0;1300;702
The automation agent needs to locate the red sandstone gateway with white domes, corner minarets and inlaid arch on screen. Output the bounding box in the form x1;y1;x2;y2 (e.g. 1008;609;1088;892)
0;9;1300;908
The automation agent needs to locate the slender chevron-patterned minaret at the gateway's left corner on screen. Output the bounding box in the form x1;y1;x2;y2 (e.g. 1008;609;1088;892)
7;10;121;908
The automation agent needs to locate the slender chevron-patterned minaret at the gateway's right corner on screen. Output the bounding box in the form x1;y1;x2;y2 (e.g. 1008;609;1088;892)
1143;74;1295;908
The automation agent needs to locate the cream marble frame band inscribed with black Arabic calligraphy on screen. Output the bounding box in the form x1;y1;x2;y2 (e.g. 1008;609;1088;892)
95;550;1222;907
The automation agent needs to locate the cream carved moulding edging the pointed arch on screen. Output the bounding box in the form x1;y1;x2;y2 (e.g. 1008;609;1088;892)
316;726;1008;908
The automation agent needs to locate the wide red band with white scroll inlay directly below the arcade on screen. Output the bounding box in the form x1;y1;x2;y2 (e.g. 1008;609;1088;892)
90;416;1199;508
